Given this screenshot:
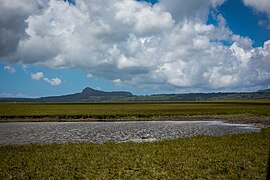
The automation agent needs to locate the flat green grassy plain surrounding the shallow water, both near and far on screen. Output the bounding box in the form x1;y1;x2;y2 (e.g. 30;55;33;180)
0;101;270;179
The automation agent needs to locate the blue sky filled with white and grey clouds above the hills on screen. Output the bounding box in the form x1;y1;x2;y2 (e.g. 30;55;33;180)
0;0;270;97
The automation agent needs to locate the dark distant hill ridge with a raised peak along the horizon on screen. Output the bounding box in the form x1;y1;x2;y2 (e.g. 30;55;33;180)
0;87;270;102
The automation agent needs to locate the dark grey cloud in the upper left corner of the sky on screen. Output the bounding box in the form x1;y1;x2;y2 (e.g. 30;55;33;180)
0;0;47;58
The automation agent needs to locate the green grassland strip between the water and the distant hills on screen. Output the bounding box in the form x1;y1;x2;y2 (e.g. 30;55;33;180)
0;101;270;120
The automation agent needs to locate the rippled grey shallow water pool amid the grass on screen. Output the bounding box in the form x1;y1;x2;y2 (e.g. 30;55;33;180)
0;121;260;145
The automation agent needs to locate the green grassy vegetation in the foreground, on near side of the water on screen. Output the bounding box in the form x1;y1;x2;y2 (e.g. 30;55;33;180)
0;129;270;179
